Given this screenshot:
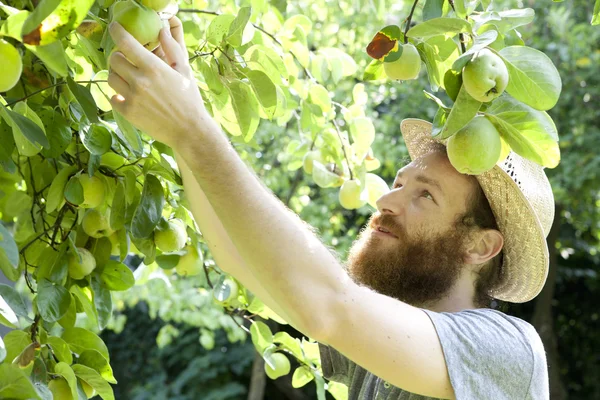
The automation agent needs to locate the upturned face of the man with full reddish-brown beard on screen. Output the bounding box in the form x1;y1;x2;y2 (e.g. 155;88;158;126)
345;152;477;307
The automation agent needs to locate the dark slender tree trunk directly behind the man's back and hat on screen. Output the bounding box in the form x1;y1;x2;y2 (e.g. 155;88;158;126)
531;205;567;400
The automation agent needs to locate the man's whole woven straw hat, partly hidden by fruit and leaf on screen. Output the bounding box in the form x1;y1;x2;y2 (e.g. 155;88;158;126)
400;118;554;303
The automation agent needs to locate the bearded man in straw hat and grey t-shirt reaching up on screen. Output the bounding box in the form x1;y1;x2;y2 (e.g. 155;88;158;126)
108;18;554;400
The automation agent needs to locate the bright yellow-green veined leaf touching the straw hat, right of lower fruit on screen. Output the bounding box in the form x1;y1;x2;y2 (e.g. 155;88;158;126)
485;96;560;168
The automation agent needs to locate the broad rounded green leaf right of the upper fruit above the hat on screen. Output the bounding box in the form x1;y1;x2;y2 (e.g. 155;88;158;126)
499;46;562;111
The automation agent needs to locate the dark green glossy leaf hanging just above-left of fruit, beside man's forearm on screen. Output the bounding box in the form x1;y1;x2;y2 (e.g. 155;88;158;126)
131;174;165;239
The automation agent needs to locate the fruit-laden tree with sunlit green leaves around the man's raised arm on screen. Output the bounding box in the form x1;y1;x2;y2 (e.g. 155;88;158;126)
0;0;576;400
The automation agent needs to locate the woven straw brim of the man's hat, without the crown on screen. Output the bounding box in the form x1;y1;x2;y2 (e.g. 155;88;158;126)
400;118;554;303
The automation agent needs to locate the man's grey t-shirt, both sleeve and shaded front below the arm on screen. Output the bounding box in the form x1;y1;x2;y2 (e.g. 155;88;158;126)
319;308;550;400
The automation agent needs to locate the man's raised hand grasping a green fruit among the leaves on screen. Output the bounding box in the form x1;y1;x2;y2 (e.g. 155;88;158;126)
108;17;211;148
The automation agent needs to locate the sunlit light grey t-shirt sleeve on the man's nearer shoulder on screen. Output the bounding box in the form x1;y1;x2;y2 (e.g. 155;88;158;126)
423;309;550;400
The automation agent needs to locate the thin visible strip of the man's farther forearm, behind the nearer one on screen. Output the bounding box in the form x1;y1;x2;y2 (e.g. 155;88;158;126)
176;154;298;329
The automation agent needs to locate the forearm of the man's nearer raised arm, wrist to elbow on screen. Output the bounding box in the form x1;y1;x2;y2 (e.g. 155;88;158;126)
179;120;347;337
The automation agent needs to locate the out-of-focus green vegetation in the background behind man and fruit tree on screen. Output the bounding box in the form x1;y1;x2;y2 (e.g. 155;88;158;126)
3;0;600;400
